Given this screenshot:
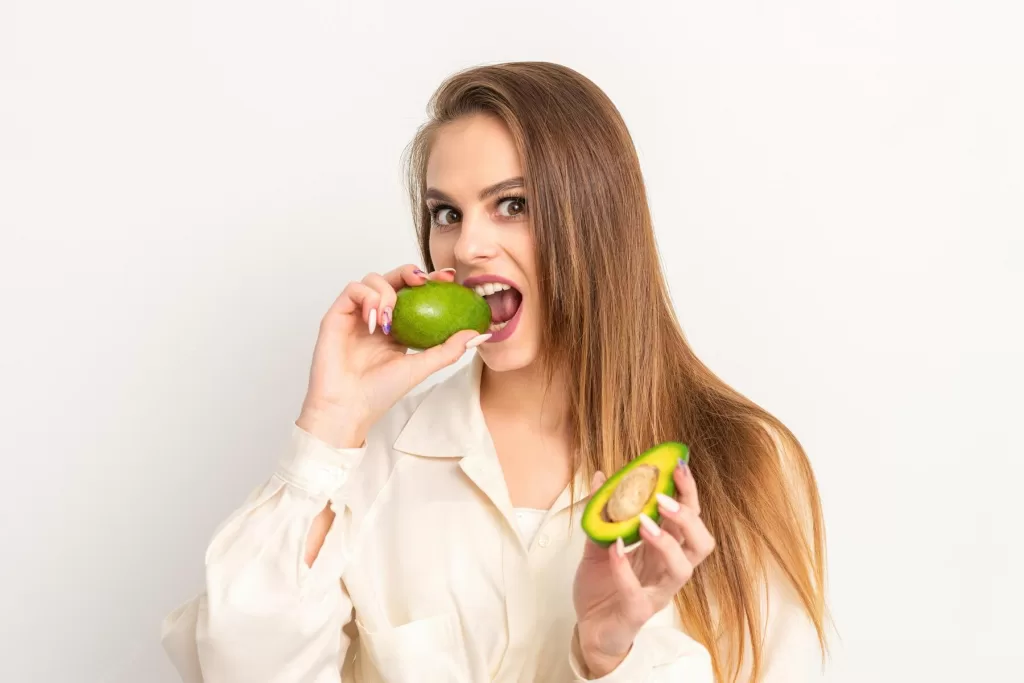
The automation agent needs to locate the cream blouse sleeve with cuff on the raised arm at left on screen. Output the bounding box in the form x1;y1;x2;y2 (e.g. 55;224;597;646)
162;426;365;683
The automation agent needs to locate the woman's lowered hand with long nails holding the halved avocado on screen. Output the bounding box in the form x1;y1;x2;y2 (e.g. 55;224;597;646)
572;465;715;678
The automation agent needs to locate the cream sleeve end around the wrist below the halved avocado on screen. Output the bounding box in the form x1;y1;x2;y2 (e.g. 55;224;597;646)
569;604;715;683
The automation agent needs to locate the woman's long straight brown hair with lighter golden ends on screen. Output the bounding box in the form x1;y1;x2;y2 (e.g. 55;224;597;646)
407;62;825;681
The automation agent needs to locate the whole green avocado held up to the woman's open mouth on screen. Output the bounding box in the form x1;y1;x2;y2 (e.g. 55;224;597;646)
391;281;490;350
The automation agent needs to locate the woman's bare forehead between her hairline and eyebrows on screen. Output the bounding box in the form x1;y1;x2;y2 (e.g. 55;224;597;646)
427;114;522;194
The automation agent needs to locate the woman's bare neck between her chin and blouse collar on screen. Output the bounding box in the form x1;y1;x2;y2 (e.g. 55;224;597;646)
480;362;568;434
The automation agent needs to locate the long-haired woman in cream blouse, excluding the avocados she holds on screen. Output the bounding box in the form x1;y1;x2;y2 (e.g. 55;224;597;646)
164;62;824;683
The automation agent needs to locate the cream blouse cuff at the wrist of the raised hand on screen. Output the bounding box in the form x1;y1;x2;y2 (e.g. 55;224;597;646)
278;425;367;496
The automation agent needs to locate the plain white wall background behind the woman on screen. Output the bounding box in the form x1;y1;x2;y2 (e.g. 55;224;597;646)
0;0;1024;683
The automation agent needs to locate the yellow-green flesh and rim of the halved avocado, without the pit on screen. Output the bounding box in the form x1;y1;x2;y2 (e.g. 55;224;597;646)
581;441;690;548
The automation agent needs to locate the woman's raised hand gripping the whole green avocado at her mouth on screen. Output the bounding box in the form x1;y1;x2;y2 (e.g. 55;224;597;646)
296;265;489;449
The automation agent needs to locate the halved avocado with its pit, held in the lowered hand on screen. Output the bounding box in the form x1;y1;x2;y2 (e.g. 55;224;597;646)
582;441;690;548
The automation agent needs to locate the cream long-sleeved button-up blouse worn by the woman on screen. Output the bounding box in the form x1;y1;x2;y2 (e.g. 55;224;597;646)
163;357;819;683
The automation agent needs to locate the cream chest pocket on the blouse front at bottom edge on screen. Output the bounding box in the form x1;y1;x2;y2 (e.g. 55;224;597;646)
355;612;472;683
